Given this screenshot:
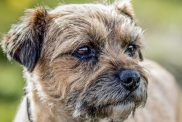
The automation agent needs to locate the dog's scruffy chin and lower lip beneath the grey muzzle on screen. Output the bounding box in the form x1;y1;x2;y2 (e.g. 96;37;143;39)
73;80;147;120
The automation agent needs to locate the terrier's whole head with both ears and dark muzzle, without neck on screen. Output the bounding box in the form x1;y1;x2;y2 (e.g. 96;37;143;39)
2;2;147;120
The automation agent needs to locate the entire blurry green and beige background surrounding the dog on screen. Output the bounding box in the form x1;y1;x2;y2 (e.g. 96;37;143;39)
0;0;182;122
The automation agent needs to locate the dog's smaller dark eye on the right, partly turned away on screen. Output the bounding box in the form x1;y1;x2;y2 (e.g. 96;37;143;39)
125;44;137;57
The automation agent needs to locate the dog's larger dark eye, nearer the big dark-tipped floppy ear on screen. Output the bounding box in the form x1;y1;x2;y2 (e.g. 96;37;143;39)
72;46;96;61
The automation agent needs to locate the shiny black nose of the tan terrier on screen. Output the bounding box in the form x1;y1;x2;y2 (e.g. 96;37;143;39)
119;69;140;91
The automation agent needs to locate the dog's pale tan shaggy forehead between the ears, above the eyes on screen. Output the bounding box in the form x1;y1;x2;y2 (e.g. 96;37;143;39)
45;4;143;55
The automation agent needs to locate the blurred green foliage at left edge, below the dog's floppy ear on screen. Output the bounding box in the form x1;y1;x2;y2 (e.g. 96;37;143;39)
0;63;24;122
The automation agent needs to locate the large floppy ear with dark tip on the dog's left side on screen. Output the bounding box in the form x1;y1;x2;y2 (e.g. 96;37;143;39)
2;7;48;71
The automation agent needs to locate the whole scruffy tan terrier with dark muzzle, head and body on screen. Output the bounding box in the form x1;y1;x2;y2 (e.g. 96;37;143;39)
2;0;178;122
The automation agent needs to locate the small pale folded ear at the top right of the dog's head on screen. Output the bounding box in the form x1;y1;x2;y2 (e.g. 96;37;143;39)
114;0;134;19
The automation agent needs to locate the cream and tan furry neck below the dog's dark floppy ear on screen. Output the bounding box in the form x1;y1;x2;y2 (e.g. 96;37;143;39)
23;72;77;122
